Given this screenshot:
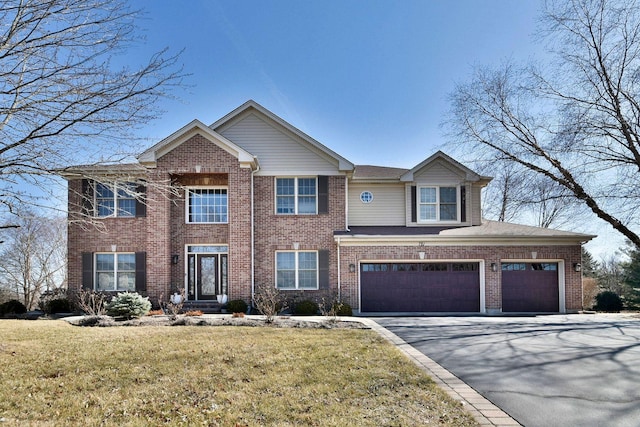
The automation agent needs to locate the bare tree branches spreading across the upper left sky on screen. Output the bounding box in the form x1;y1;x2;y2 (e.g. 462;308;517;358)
0;0;183;226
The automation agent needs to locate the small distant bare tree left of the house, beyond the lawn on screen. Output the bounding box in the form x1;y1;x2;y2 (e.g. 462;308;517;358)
0;212;66;309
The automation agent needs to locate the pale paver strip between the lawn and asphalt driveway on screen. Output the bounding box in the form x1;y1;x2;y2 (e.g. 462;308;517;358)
353;318;520;427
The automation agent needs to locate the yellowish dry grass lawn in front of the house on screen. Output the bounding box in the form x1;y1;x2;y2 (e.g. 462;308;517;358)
0;320;477;426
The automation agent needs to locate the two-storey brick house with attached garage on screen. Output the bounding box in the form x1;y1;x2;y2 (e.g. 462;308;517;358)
63;101;594;313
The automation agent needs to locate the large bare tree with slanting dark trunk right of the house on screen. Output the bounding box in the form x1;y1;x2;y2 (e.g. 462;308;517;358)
449;0;640;247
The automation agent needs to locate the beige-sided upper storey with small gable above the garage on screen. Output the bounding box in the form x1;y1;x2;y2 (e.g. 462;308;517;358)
348;151;491;228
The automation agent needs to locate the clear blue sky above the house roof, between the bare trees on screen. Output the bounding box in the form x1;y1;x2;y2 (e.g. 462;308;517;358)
123;0;622;256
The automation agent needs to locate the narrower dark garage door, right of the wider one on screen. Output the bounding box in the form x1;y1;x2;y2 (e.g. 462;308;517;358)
502;262;560;313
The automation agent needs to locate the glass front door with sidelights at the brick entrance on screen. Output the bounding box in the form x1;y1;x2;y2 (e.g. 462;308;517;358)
188;253;227;300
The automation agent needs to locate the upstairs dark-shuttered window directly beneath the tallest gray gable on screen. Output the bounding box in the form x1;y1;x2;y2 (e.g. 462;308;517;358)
276;178;318;215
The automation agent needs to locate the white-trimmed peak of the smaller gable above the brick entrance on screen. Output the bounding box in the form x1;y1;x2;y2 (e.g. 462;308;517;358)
138;119;258;169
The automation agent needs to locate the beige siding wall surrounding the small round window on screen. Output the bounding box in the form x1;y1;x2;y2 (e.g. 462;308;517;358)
349;183;406;226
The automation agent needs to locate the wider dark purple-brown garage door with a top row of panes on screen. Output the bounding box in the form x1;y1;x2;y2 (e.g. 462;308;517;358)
360;262;480;312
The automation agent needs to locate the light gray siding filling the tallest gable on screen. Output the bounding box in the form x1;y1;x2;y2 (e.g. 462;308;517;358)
218;112;338;176
